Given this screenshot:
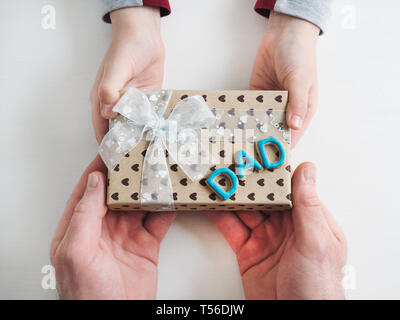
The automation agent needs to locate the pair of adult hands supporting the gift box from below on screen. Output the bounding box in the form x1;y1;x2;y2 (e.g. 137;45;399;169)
51;156;346;299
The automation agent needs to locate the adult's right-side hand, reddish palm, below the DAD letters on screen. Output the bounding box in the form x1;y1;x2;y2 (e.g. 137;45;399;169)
207;163;346;299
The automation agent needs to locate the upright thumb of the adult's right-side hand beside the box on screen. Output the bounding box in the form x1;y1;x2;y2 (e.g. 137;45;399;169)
292;162;330;253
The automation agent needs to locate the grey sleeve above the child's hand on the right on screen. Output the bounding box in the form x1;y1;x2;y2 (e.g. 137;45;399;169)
274;0;333;33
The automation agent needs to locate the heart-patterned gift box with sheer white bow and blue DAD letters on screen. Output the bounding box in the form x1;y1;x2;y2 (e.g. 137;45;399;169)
100;89;292;211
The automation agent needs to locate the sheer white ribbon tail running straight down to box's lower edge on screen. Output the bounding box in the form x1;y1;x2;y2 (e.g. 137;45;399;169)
141;136;175;211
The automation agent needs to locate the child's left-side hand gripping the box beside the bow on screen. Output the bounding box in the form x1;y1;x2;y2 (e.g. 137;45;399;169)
90;7;165;142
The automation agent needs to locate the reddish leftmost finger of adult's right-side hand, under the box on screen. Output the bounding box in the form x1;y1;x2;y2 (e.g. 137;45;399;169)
206;211;250;253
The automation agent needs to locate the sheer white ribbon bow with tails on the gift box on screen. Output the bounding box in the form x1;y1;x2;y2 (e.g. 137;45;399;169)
99;88;216;211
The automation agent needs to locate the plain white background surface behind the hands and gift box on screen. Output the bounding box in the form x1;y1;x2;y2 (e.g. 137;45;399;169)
0;0;400;299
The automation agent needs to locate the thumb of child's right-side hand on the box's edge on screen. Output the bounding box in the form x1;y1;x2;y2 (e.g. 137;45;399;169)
285;76;310;130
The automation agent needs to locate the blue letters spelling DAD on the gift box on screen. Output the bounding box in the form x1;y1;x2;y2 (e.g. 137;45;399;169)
206;137;285;200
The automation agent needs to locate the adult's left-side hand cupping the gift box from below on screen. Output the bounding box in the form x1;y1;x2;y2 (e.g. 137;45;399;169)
51;156;176;299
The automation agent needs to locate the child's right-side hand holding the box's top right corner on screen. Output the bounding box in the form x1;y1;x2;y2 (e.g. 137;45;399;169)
250;11;320;147
